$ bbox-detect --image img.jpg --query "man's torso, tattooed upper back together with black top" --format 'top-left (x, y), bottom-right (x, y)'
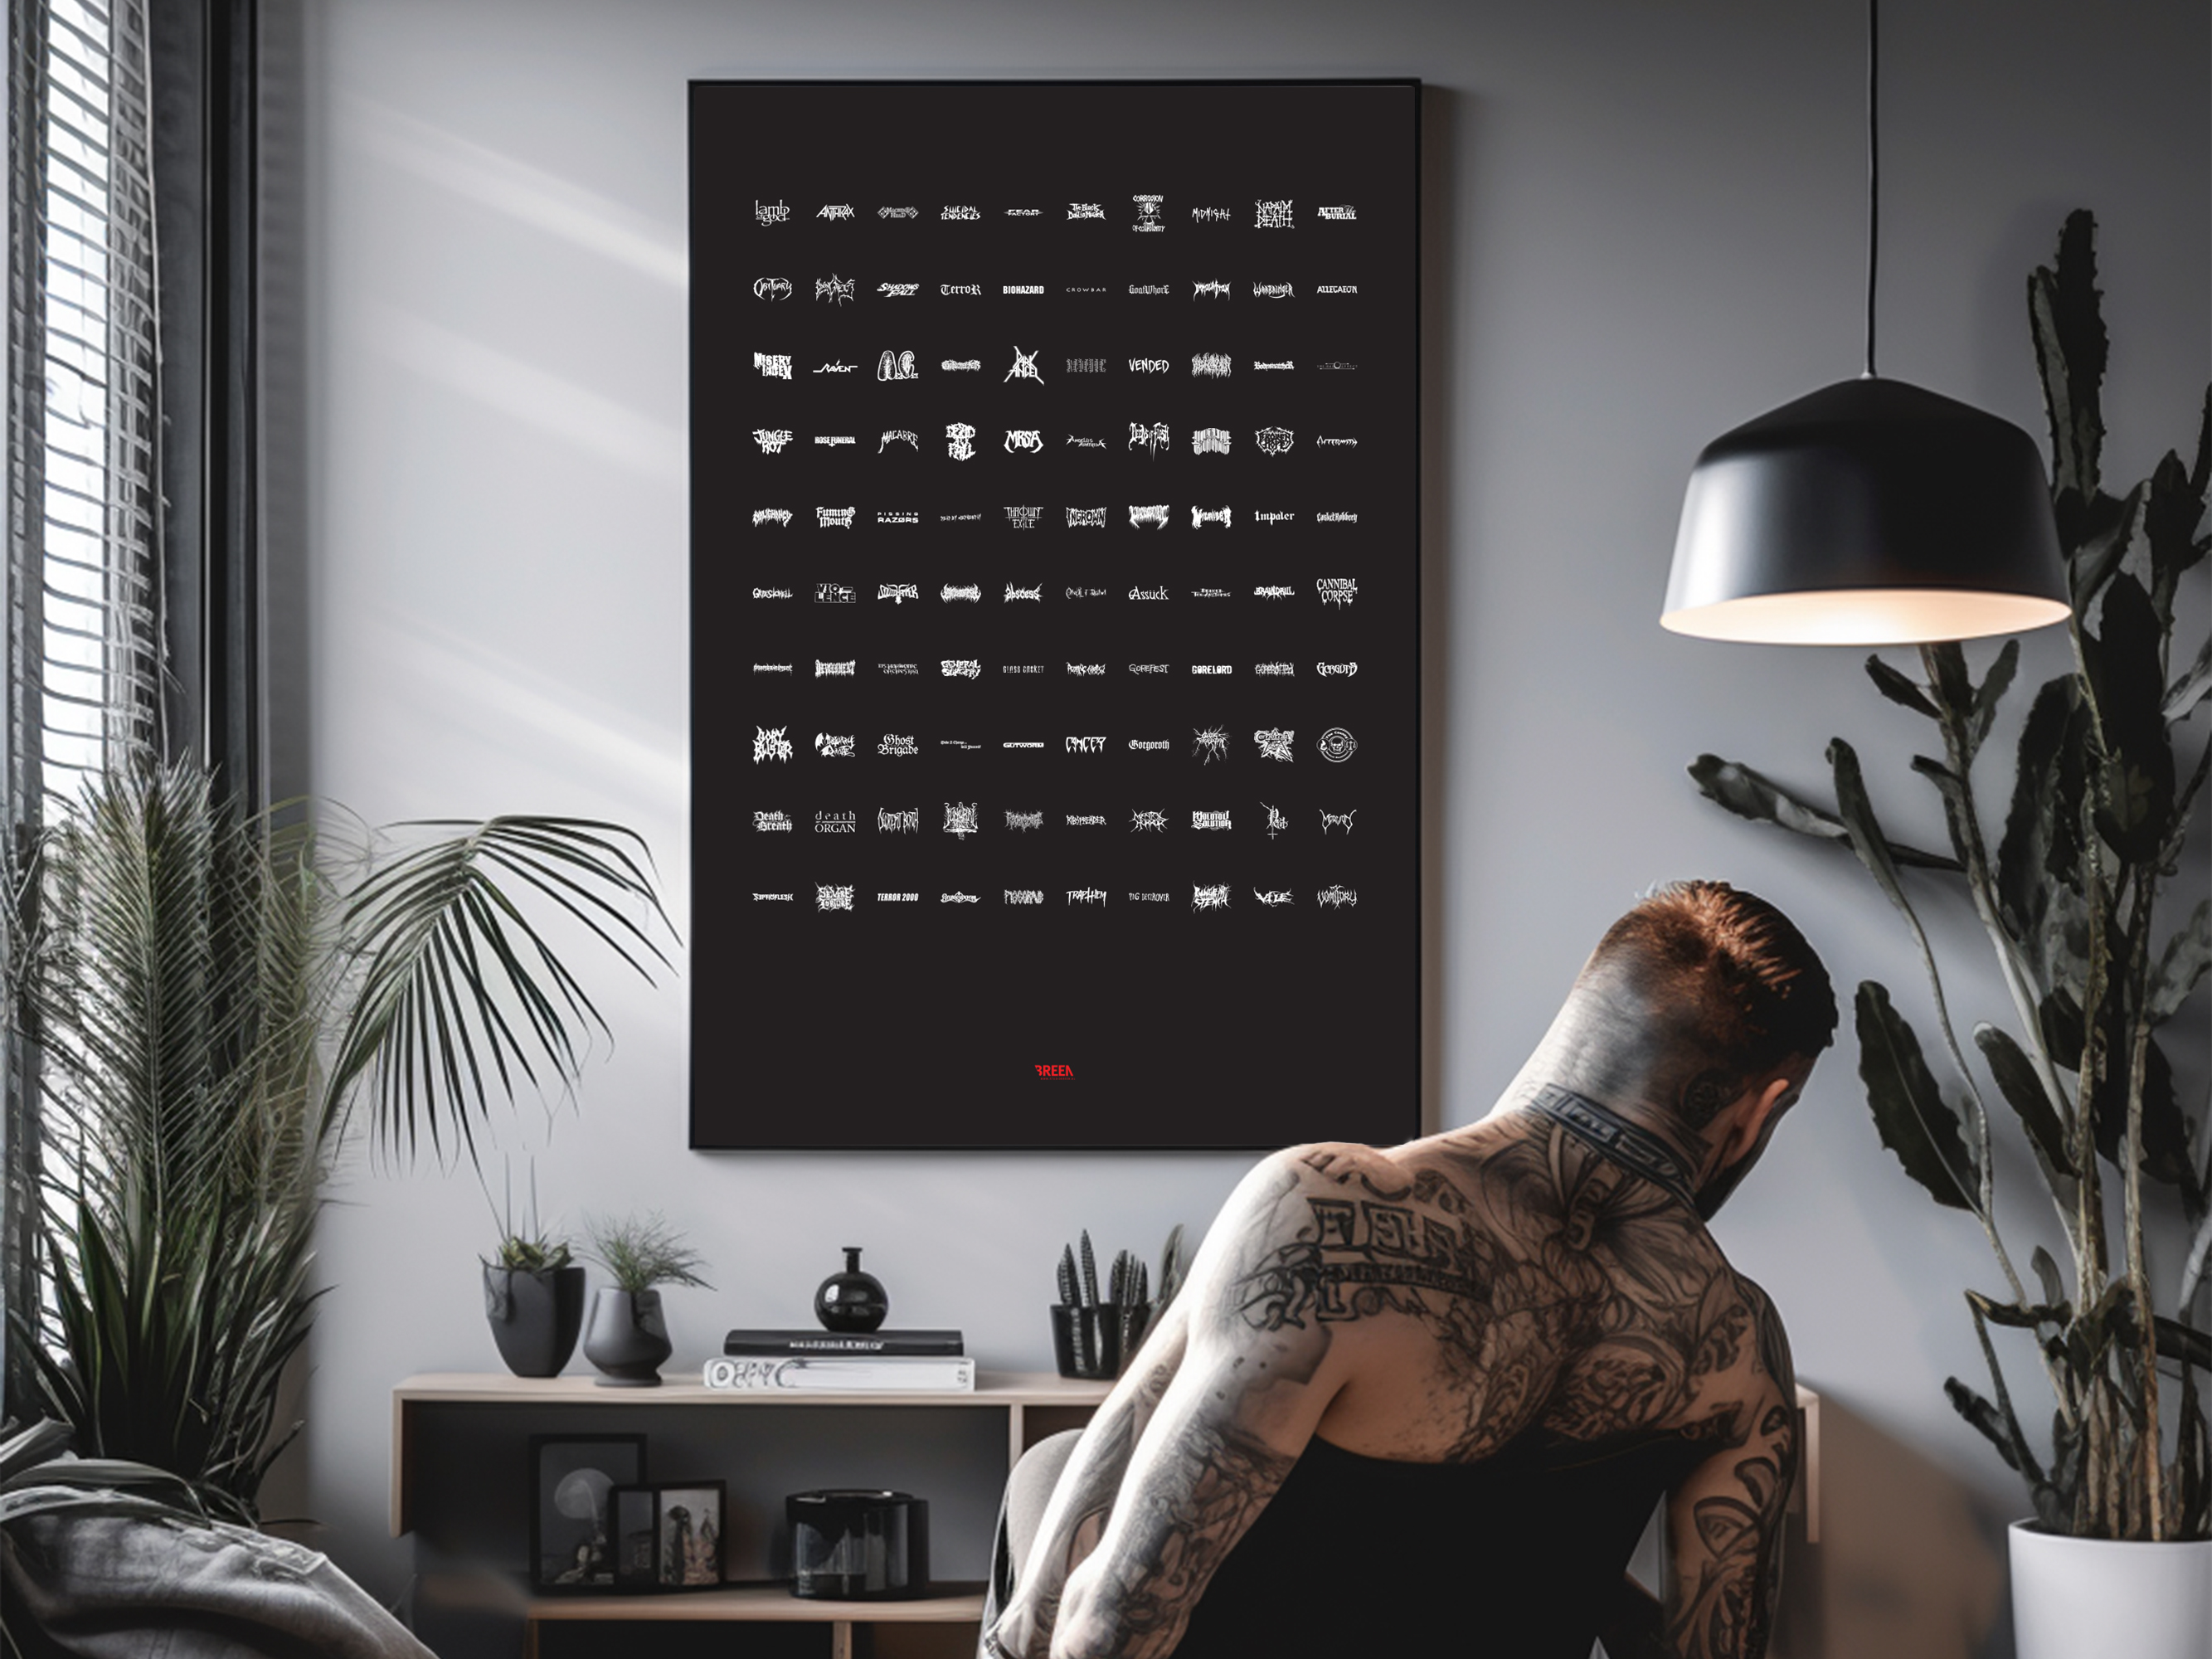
top-left (1174, 1112), bottom-right (1787, 1659)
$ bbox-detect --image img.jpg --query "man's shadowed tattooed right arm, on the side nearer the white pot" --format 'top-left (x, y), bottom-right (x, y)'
top-left (1665, 1281), bottom-right (1798, 1659)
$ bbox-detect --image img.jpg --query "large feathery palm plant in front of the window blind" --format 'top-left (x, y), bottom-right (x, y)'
top-left (0, 757), bottom-right (666, 1522)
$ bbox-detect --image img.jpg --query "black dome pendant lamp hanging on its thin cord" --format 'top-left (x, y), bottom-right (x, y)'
top-left (1659, 0), bottom-right (2073, 646)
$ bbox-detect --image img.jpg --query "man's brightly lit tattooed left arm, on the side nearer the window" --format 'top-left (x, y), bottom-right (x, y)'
top-left (999, 1152), bottom-right (1345, 1659)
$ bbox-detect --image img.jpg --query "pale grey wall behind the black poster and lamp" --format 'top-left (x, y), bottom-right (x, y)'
top-left (285, 0), bottom-right (2212, 1627)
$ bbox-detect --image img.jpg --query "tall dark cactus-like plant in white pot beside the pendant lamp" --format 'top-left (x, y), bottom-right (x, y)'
top-left (1690, 212), bottom-right (2212, 1659)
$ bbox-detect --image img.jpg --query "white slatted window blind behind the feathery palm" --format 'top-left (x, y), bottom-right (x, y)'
top-left (0, 0), bottom-right (162, 1398)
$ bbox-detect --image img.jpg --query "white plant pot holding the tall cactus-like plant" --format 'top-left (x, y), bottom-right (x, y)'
top-left (2013, 1522), bottom-right (2212, 1659)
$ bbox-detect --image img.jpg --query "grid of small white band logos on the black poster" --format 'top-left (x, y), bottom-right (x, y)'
top-left (738, 192), bottom-right (1396, 916)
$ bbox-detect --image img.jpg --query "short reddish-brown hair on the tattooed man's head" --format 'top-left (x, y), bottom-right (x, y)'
top-left (1588, 880), bottom-right (1836, 1078)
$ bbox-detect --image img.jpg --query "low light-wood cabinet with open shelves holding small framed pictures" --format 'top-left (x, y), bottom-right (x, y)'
top-left (391, 1371), bottom-right (1106, 1659)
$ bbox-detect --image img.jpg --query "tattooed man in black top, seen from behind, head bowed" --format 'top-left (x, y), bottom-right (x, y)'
top-left (984, 883), bottom-right (1836, 1659)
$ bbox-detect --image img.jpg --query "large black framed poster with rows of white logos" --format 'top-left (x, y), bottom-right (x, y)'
top-left (690, 82), bottom-right (1420, 1148)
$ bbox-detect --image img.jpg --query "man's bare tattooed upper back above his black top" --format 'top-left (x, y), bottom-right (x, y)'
top-left (1282, 1112), bottom-right (1772, 1462)
